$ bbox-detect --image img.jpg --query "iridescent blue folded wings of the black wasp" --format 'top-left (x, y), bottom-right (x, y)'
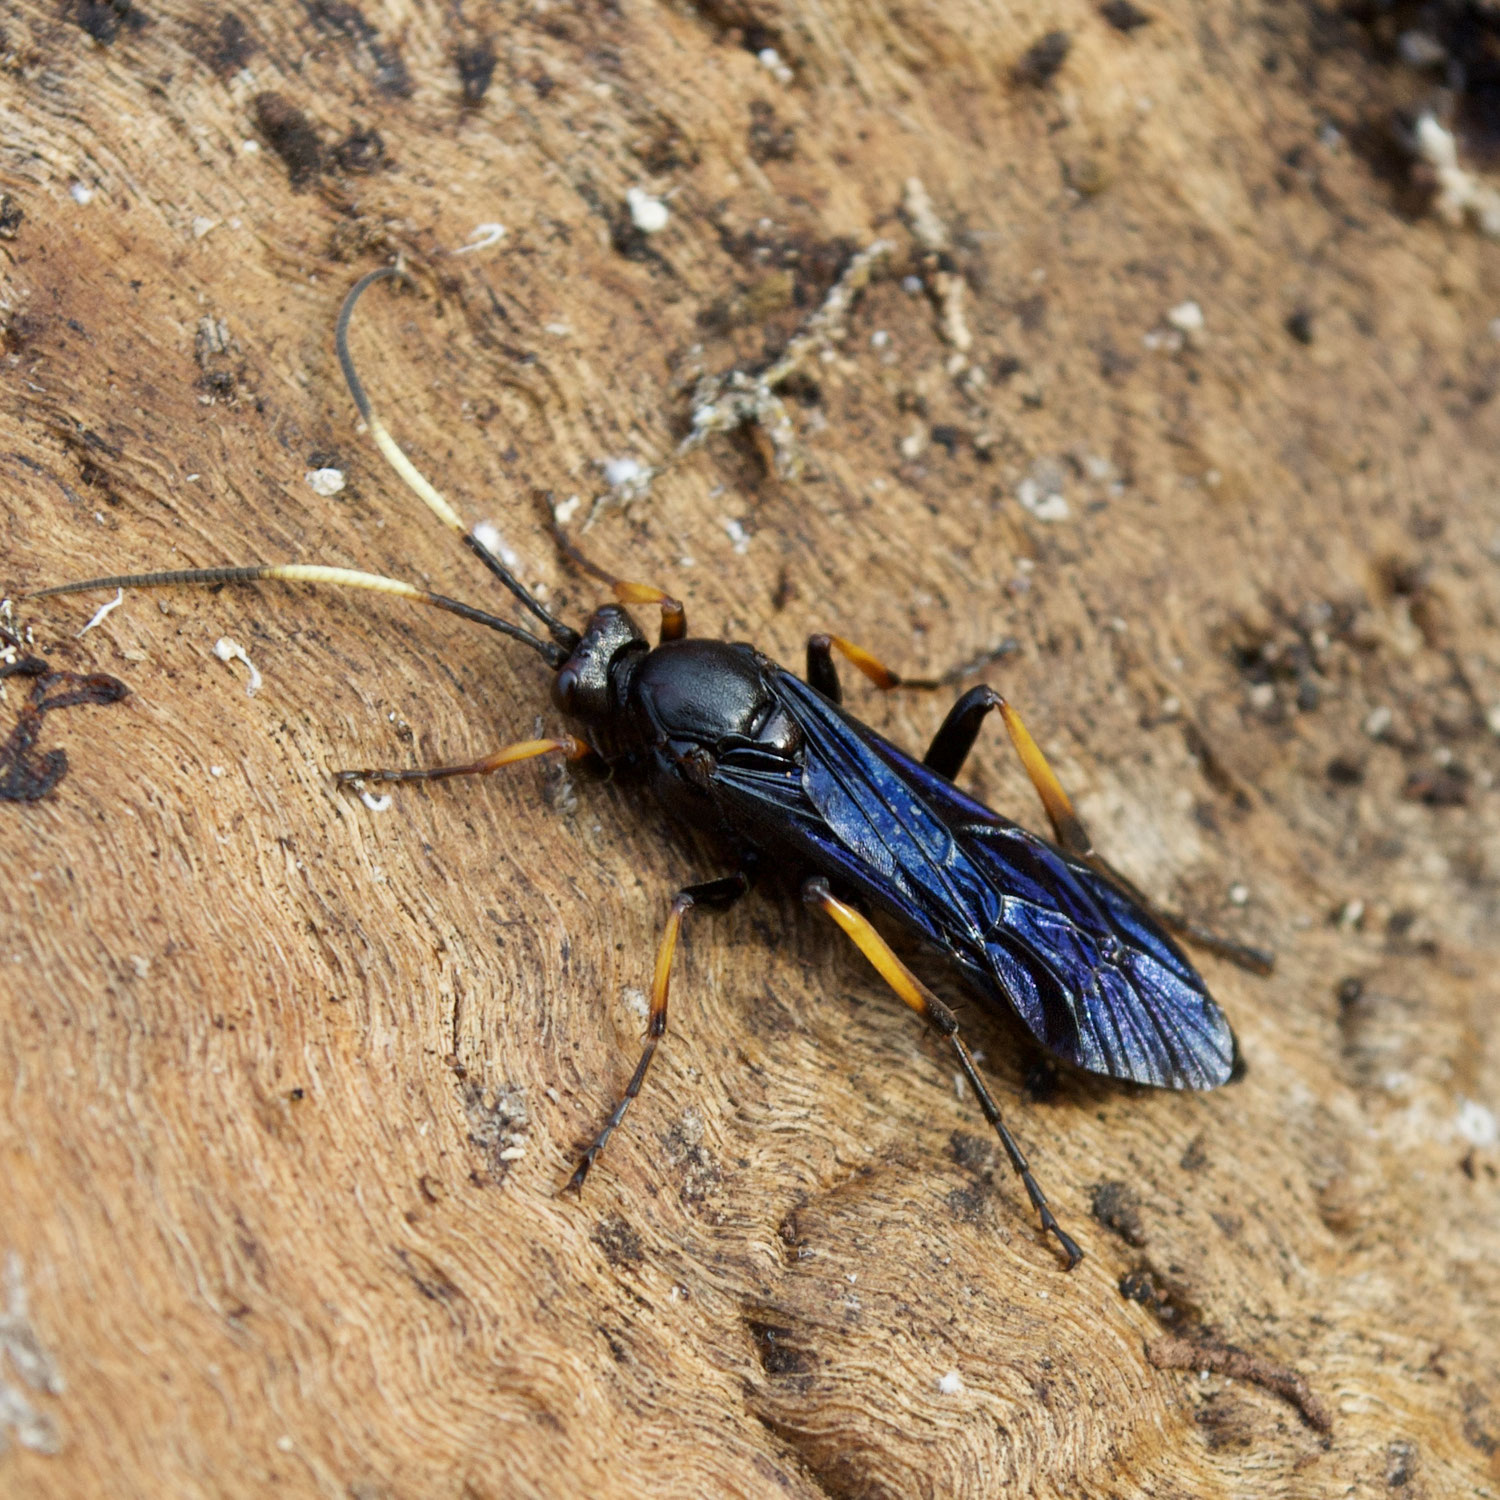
top-left (713, 669), bottom-right (1235, 1089)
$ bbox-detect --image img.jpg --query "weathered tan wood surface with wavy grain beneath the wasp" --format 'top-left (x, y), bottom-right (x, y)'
top-left (0, 0), bottom-right (1500, 1500)
